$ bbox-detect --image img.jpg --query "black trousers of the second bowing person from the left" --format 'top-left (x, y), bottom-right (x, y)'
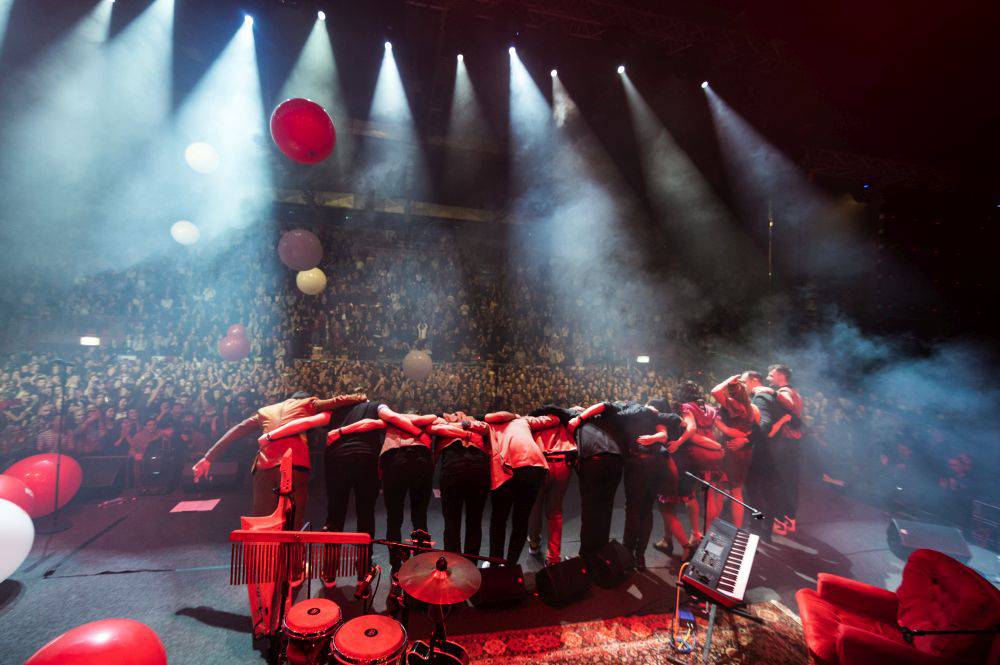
top-left (323, 448), bottom-right (379, 538)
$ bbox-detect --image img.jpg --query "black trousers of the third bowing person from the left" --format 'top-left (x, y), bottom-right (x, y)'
top-left (380, 446), bottom-right (434, 570)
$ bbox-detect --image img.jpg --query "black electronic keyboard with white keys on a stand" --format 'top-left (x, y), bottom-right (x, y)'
top-left (681, 519), bottom-right (760, 608)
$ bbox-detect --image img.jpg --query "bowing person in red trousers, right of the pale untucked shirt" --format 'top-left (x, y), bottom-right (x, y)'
top-left (528, 404), bottom-right (576, 565)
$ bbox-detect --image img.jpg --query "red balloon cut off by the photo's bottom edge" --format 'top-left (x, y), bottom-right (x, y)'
top-left (24, 619), bottom-right (167, 665)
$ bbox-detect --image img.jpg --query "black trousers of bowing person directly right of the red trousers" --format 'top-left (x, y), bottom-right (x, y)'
top-left (576, 455), bottom-right (624, 556)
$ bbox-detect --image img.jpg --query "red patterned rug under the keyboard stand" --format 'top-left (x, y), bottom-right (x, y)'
top-left (450, 600), bottom-right (807, 665)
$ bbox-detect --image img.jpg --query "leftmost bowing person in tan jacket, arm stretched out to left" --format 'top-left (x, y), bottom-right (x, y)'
top-left (193, 391), bottom-right (367, 528)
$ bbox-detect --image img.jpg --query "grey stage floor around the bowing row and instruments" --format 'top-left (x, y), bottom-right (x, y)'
top-left (0, 476), bottom-right (1000, 665)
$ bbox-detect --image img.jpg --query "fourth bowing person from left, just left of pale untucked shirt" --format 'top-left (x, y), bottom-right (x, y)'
top-left (435, 411), bottom-right (492, 556)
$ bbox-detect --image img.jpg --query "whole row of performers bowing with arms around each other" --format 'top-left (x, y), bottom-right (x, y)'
top-left (194, 379), bottom-right (800, 569)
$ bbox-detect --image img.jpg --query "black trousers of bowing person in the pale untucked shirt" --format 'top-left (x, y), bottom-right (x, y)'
top-left (490, 466), bottom-right (546, 566)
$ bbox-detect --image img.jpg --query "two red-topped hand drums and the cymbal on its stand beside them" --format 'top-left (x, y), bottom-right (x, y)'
top-left (282, 551), bottom-right (482, 665)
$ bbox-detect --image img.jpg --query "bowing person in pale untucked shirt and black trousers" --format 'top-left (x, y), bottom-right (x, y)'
top-left (483, 411), bottom-right (549, 566)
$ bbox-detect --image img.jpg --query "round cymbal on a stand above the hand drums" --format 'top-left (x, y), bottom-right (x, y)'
top-left (399, 552), bottom-right (483, 605)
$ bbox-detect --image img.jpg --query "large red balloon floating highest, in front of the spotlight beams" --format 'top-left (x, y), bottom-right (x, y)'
top-left (271, 98), bottom-right (337, 164)
